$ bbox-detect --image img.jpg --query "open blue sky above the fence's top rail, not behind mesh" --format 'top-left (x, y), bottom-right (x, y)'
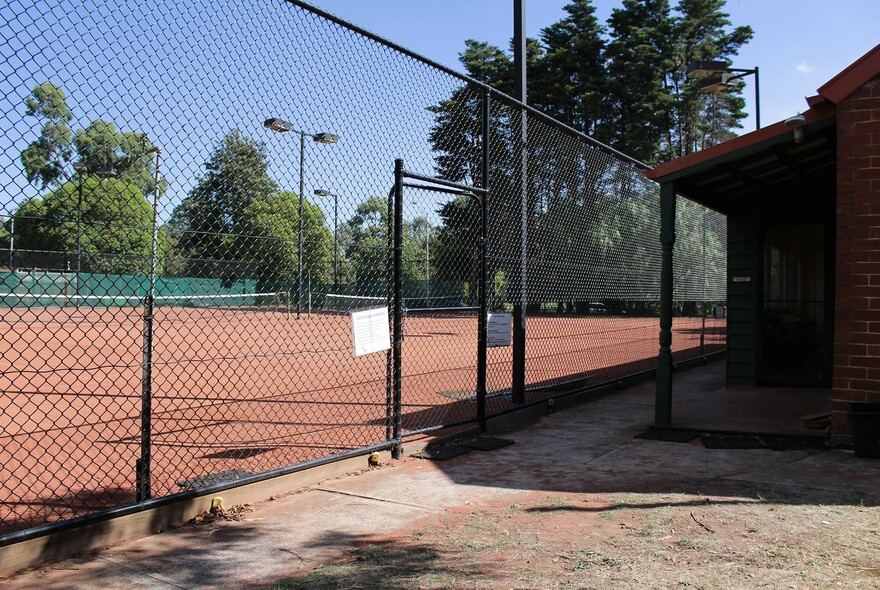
top-left (312, 0), bottom-right (880, 132)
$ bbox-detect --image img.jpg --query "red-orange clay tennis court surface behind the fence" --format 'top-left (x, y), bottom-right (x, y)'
top-left (0, 307), bottom-right (724, 533)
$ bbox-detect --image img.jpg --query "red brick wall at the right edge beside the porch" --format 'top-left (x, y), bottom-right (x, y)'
top-left (831, 77), bottom-right (880, 441)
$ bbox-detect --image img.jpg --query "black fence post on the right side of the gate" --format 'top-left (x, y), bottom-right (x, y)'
top-left (477, 89), bottom-right (490, 432)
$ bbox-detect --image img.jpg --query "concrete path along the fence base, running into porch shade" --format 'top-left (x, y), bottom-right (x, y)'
top-left (0, 369), bottom-right (880, 590)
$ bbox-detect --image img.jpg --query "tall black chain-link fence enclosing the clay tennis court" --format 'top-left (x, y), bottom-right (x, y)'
top-left (0, 0), bottom-right (726, 543)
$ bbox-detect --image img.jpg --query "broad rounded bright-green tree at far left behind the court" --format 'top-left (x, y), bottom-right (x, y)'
top-left (14, 175), bottom-right (153, 274)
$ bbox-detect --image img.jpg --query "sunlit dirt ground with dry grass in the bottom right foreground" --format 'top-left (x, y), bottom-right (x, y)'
top-left (267, 482), bottom-right (880, 590)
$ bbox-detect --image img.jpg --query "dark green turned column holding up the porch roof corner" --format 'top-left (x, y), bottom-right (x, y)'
top-left (654, 182), bottom-right (675, 426)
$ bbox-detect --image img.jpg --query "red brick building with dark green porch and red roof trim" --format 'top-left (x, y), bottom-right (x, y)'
top-left (648, 45), bottom-right (880, 441)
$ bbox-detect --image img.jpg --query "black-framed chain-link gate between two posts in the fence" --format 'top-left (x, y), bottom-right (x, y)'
top-left (388, 160), bottom-right (488, 450)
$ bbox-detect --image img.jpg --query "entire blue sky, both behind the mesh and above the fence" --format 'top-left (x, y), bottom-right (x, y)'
top-left (0, 0), bottom-right (880, 229)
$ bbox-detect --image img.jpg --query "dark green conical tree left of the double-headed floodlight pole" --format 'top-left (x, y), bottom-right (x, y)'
top-left (171, 129), bottom-right (278, 275)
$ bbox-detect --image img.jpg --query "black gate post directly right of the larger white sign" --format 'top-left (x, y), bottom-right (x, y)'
top-left (391, 159), bottom-right (403, 459)
